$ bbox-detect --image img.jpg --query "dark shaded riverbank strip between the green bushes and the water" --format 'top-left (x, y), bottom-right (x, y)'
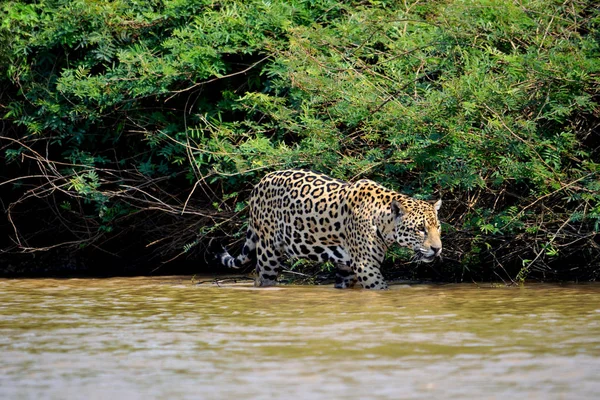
top-left (0, 250), bottom-right (600, 285)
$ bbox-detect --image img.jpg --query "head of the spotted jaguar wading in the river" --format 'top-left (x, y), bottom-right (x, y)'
top-left (391, 198), bottom-right (442, 263)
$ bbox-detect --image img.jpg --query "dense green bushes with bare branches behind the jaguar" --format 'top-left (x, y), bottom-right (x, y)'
top-left (0, 0), bottom-right (600, 280)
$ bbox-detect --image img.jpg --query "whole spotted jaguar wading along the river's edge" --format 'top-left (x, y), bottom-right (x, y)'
top-left (218, 170), bottom-right (442, 289)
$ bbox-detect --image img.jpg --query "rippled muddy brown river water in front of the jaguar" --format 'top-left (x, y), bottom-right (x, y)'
top-left (0, 277), bottom-right (600, 399)
